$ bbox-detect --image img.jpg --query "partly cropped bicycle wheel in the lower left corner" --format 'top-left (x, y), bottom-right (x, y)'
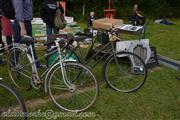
top-left (0, 80), bottom-right (26, 120)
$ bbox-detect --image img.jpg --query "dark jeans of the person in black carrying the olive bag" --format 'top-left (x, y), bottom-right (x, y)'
top-left (46, 25), bottom-right (59, 49)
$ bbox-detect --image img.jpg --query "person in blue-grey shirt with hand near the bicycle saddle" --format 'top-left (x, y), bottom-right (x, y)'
top-left (11, 0), bottom-right (42, 68)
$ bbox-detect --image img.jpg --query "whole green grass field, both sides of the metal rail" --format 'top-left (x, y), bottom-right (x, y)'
top-left (0, 20), bottom-right (180, 120)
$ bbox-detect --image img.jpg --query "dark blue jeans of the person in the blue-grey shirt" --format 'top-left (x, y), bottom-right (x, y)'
top-left (13, 20), bottom-right (41, 67)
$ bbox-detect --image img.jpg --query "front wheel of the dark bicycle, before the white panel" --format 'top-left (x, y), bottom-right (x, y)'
top-left (102, 52), bottom-right (147, 93)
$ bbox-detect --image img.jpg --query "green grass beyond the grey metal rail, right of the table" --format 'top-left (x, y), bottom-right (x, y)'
top-left (147, 20), bottom-right (180, 61)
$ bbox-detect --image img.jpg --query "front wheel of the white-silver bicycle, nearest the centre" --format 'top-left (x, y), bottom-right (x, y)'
top-left (48, 62), bottom-right (99, 112)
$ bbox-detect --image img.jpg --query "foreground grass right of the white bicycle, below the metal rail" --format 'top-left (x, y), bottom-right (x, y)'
top-left (26, 67), bottom-right (180, 120)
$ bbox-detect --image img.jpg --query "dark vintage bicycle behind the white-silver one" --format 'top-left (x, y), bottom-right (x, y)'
top-left (70, 28), bottom-right (148, 93)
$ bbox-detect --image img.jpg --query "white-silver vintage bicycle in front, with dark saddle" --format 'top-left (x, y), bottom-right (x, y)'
top-left (7, 36), bottom-right (99, 112)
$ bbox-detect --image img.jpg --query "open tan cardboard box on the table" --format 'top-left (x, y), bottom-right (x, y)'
top-left (93, 18), bottom-right (123, 30)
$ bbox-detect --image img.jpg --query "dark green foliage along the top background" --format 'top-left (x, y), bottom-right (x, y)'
top-left (33, 0), bottom-right (180, 19)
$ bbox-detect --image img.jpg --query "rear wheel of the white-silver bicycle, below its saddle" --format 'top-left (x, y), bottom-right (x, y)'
top-left (8, 48), bottom-right (32, 89)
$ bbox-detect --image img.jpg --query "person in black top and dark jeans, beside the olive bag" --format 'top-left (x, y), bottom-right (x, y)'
top-left (40, 0), bottom-right (64, 49)
